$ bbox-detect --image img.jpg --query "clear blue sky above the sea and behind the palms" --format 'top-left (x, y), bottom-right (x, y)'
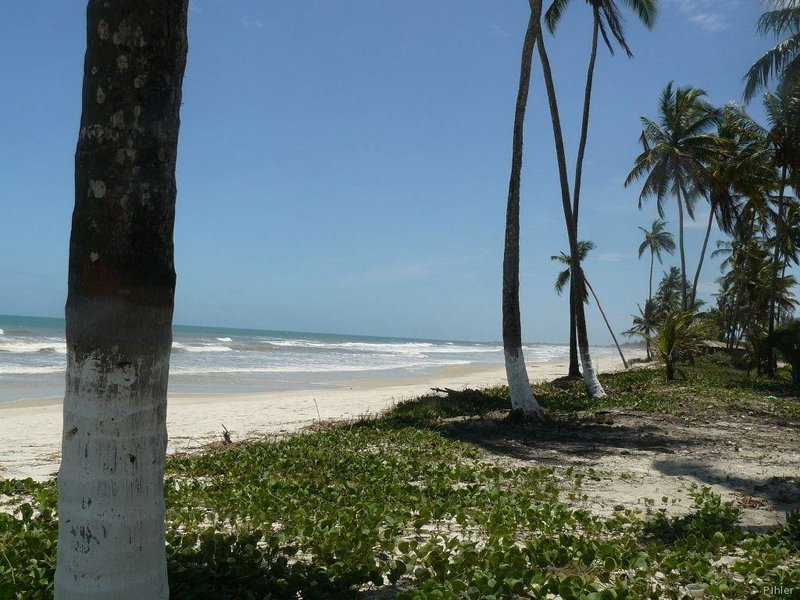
top-left (0, 0), bottom-right (788, 344)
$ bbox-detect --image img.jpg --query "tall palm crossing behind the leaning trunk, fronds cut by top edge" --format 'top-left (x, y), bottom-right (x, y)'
top-left (545, 0), bottom-right (657, 377)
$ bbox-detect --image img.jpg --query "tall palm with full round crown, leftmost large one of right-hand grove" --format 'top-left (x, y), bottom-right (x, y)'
top-left (625, 82), bottom-right (718, 310)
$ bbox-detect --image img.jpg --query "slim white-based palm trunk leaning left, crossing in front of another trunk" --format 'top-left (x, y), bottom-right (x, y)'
top-left (537, 35), bottom-right (606, 398)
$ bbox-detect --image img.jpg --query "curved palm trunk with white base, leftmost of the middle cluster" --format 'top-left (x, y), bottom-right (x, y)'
top-left (503, 0), bottom-right (542, 418)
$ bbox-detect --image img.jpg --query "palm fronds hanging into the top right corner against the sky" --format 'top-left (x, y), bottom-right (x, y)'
top-left (744, 0), bottom-right (800, 100)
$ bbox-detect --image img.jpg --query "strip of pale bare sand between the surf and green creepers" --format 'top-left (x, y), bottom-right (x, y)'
top-left (0, 350), bottom-right (641, 480)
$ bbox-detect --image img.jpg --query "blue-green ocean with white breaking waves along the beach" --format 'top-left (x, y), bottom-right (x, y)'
top-left (0, 315), bottom-right (612, 402)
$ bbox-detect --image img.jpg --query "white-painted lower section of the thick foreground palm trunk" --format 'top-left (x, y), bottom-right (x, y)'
top-left (56, 351), bottom-right (169, 600)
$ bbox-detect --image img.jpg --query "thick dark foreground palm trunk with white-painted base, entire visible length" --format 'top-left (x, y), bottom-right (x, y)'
top-left (55, 0), bottom-right (188, 599)
